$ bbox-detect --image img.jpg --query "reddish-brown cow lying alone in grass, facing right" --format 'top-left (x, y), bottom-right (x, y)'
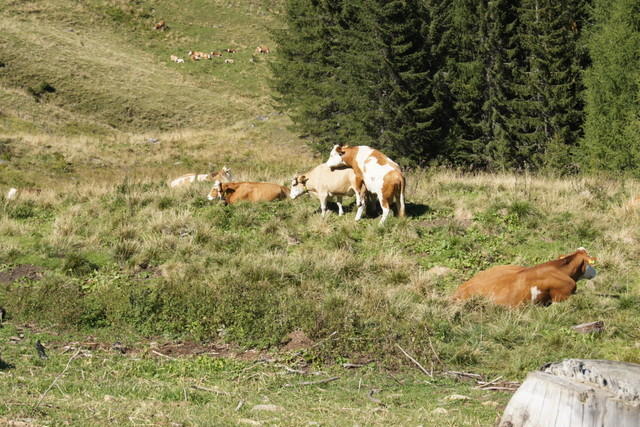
top-left (454, 248), bottom-right (596, 307)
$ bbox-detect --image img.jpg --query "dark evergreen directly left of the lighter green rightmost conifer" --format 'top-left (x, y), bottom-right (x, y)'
top-left (513, 0), bottom-right (585, 168)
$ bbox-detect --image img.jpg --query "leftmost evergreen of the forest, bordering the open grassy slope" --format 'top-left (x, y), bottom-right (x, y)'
top-left (272, 0), bottom-right (352, 153)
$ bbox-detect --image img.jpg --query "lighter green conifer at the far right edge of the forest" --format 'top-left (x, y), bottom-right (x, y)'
top-left (581, 0), bottom-right (640, 173)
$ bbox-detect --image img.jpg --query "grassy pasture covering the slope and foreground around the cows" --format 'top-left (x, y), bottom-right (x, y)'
top-left (0, 0), bottom-right (640, 425)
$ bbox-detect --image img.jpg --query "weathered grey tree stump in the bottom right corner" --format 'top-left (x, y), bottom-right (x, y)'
top-left (499, 359), bottom-right (640, 427)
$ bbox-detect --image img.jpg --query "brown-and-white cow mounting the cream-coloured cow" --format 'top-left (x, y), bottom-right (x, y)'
top-left (326, 145), bottom-right (406, 224)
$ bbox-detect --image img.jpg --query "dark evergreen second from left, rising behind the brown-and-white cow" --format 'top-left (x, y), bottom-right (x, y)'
top-left (358, 0), bottom-right (447, 164)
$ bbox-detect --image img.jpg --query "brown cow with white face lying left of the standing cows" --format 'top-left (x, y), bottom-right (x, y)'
top-left (208, 181), bottom-right (289, 205)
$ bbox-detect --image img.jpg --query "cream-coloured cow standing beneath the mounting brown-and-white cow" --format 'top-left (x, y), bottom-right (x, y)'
top-left (291, 163), bottom-right (361, 216)
